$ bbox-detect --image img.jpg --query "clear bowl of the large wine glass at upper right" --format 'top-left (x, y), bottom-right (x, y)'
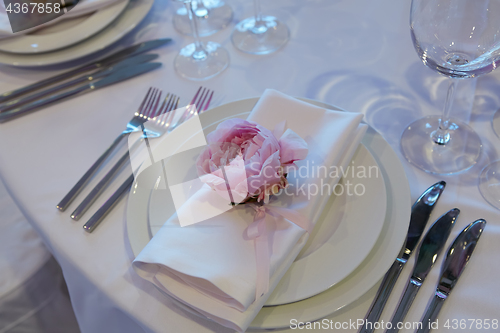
top-left (410, 0), bottom-right (500, 78)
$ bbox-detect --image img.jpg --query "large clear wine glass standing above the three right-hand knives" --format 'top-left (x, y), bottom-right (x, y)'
top-left (401, 0), bottom-right (500, 174)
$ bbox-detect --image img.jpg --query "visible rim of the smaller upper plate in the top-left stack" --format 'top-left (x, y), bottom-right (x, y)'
top-left (0, 0), bottom-right (129, 54)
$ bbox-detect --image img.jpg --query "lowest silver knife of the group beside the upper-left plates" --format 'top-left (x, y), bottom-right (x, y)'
top-left (0, 62), bottom-right (161, 122)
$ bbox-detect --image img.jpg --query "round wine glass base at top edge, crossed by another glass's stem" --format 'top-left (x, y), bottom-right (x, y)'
top-left (173, 0), bottom-right (233, 37)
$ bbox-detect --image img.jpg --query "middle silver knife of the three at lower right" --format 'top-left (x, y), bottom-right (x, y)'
top-left (385, 208), bottom-right (460, 333)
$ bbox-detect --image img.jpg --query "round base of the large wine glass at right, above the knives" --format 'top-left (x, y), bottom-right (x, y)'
top-left (401, 116), bottom-right (482, 174)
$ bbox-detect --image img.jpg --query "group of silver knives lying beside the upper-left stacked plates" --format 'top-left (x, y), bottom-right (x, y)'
top-left (0, 39), bottom-right (171, 122)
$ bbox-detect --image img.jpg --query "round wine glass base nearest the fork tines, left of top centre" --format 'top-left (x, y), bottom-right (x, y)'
top-left (174, 42), bottom-right (229, 81)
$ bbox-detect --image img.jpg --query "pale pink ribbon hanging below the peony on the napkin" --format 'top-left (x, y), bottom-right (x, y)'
top-left (247, 204), bottom-right (313, 299)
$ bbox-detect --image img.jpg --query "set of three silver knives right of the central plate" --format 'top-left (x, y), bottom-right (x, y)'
top-left (358, 181), bottom-right (486, 333)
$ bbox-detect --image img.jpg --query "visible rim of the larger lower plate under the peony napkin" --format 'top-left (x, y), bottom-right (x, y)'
top-left (127, 98), bottom-right (410, 328)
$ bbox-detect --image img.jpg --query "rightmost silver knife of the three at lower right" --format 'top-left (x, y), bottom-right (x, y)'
top-left (415, 219), bottom-right (486, 333)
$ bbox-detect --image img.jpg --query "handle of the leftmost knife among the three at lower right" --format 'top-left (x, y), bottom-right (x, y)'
top-left (358, 258), bottom-right (406, 333)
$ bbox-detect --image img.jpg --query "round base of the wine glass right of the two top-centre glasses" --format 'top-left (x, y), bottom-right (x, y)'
top-left (231, 16), bottom-right (290, 54)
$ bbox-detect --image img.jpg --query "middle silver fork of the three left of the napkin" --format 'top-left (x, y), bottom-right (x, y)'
top-left (71, 91), bottom-right (179, 221)
